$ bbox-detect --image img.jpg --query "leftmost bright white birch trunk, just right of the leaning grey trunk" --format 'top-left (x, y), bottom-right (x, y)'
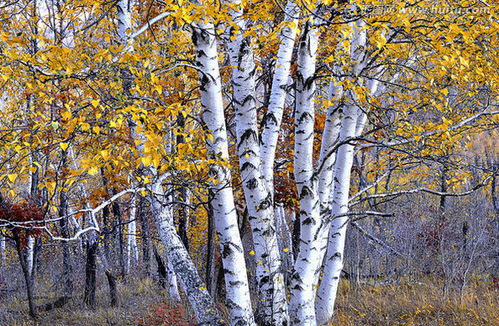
top-left (192, 24), bottom-right (255, 325)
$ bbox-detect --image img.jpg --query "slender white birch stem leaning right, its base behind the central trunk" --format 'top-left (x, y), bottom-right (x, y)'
top-left (260, 0), bottom-right (299, 190)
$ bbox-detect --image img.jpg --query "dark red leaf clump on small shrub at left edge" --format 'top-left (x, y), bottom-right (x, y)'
top-left (0, 202), bottom-right (43, 248)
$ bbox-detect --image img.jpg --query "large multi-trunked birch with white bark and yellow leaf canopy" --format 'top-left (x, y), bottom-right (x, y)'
top-left (0, 0), bottom-right (497, 325)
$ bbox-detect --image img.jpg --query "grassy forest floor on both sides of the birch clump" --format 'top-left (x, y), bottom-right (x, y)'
top-left (0, 279), bottom-right (499, 326)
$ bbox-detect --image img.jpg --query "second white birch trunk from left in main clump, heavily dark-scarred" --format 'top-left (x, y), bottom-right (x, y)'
top-left (229, 2), bottom-right (289, 326)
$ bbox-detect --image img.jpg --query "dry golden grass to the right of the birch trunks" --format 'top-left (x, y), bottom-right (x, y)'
top-left (332, 281), bottom-right (499, 326)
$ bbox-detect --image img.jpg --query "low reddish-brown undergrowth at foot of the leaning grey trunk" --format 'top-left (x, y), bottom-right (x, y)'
top-left (137, 303), bottom-right (196, 326)
